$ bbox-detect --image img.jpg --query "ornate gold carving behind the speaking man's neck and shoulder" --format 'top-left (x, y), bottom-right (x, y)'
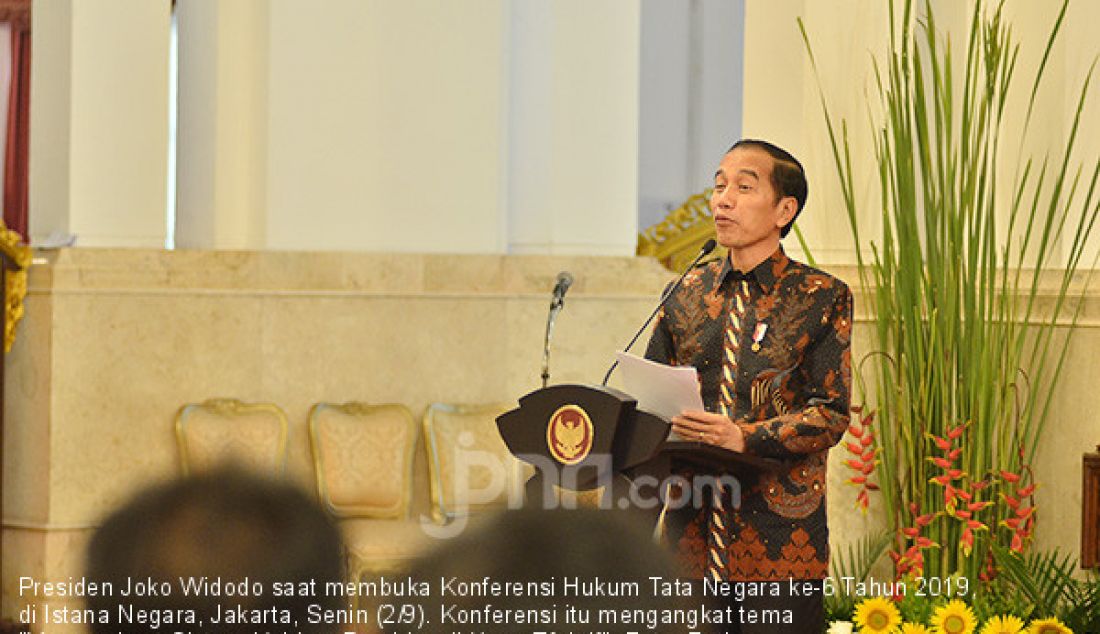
top-left (637, 189), bottom-right (724, 273)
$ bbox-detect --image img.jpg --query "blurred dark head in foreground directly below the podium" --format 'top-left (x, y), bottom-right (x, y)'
top-left (387, 509), bottom-right (723, 634)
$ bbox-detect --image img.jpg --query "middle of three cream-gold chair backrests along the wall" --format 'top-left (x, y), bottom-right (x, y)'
top-left (309, 402), bottom-right (417, 517)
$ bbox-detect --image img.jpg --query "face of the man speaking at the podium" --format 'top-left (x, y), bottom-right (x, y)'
top-left (711, 146), bottom-right (798, 251)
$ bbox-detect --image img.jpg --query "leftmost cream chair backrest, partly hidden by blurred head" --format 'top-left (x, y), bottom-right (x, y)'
top-left (175, 398), bottom-right (287, 477)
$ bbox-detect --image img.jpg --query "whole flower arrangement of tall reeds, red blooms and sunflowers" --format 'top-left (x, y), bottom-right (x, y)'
top-left (799, 0), bottom-right (1100, 634)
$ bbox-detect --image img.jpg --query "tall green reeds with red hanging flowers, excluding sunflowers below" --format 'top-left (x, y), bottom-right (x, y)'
top-left (799, 0), bottom-right (1100, 579)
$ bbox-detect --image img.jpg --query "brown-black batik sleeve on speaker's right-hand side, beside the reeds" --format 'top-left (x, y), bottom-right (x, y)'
top-left (736, 283), bottom-right (851, 460)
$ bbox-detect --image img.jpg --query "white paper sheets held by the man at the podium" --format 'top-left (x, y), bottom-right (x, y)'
top-left (616, 352), bottom-right (704, 429)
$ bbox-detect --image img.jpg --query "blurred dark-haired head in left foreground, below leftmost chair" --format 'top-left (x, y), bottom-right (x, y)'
top-left (87, 469), bottom-right (344, 634)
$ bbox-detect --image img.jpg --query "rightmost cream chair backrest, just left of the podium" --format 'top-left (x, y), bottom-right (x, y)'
top-left (424, 403), bottom-right (530, 523)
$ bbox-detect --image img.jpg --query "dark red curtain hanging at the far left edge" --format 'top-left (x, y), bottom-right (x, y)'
top-left (0, 0), bottom-right (31, 240)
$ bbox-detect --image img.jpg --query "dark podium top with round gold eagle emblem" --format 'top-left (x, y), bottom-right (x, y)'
top-left (496, 384), bottom-right (782, 507)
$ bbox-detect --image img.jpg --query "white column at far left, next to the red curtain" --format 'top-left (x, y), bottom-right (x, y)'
top-left (29, 0), bottom-right (171, 248)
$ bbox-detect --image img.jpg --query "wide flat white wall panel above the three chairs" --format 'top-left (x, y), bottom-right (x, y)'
top-left (266, 0), bottom-right (507, 253)
